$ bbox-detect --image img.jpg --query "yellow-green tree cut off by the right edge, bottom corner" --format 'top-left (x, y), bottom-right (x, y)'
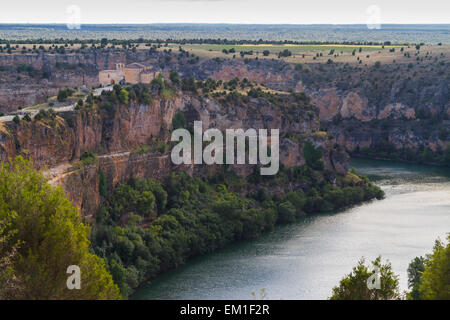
top-left (419, 234), bottom-right (450, 300)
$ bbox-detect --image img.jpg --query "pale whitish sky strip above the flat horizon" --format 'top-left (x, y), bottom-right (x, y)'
top-left (0, 0), bottom-right (450, 24)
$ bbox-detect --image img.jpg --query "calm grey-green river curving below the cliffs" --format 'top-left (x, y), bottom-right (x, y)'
top-left (133, 159), bottom-right (450, 300)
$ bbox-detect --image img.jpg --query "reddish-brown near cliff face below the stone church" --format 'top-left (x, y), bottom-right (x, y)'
top-left (0, 92), bottom-right (348, 216)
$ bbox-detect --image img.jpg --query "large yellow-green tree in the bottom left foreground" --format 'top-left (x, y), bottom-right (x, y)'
top-left (0, 157), bottom-right (120, 299)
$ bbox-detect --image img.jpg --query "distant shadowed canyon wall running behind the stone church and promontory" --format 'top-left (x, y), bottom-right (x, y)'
top-left (0, 49), bottom-right (450, 157)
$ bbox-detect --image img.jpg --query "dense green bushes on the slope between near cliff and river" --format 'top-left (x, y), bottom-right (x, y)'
top-left (92, 166), bottom-right (383, 297)
